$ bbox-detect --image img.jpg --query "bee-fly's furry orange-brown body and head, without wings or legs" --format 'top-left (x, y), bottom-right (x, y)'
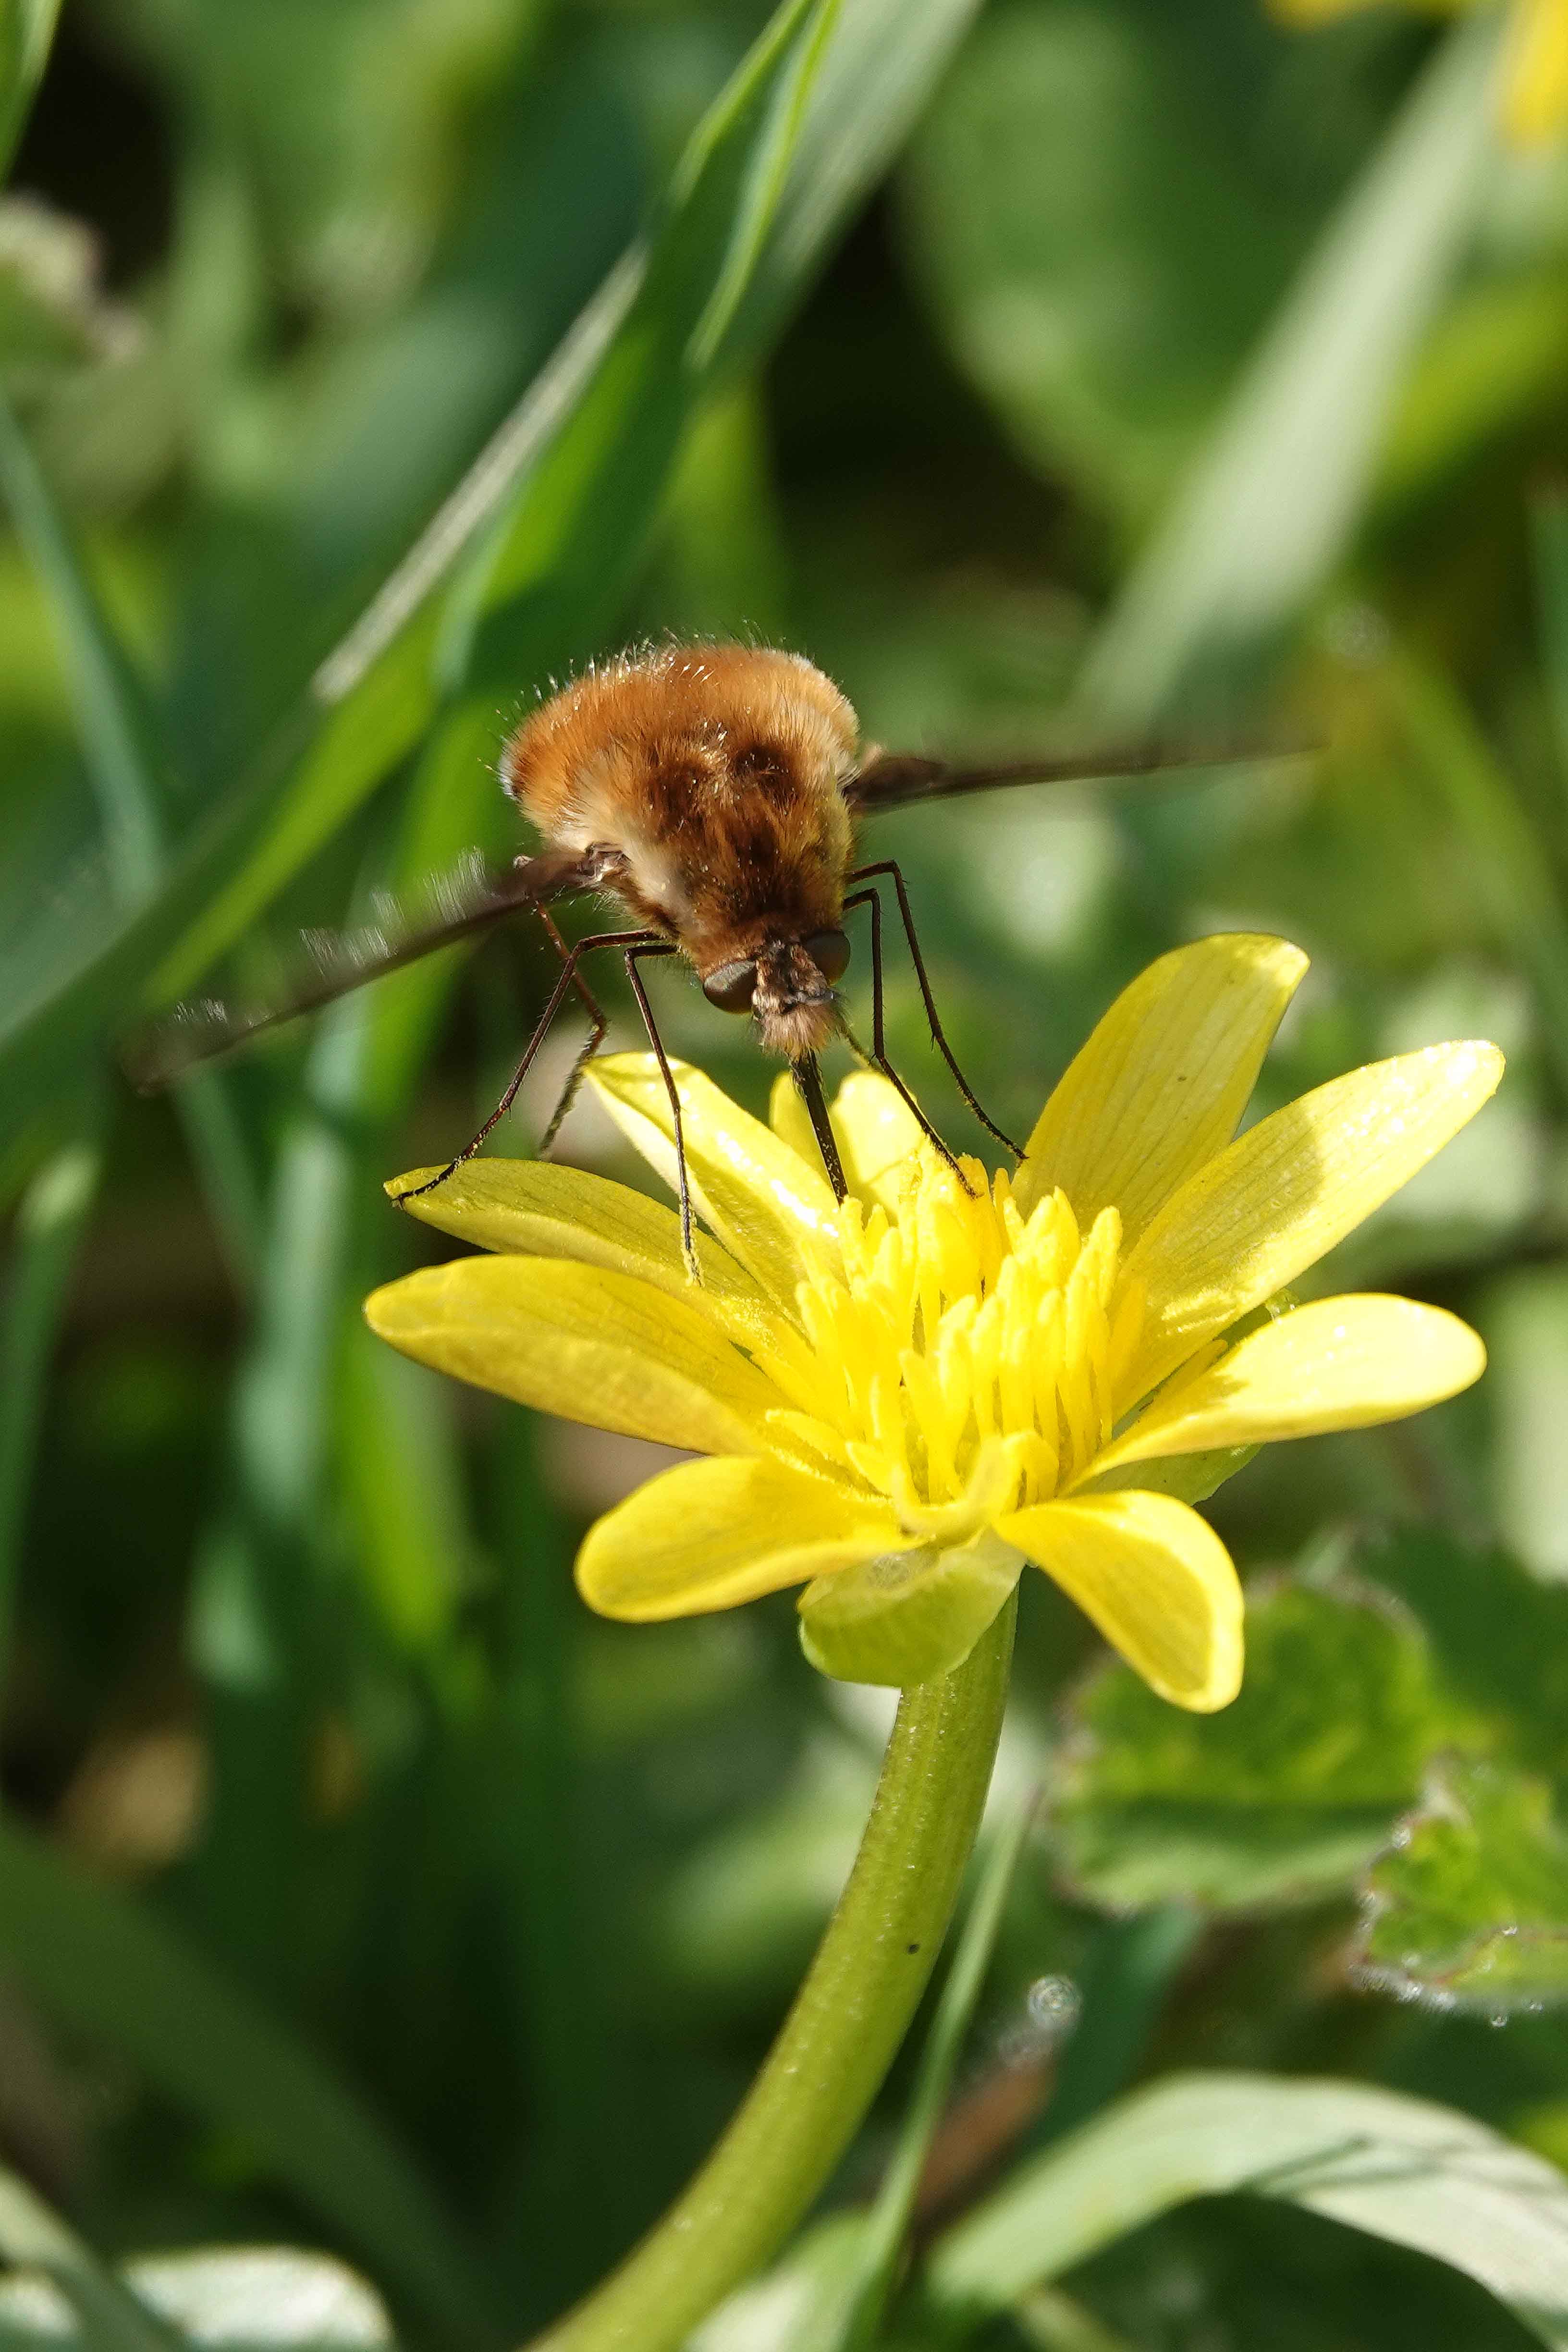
top-left (501, 645), bottom-right (860, 1061)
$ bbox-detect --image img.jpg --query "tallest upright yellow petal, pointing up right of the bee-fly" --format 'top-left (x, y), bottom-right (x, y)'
top-left (1013, 931), bottom-right (1307, 1249)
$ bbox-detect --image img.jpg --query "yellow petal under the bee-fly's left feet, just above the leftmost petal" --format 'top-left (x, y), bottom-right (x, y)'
top-left (386, 1160), bottom-right (769, 1329)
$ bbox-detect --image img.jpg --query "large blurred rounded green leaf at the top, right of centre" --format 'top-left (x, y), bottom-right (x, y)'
top-left (905, 0), bottom-right (1300, 525)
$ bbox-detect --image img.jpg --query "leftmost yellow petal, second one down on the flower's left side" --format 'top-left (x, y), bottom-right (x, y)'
top-left (365, 1258), bottom-right (783, 1454)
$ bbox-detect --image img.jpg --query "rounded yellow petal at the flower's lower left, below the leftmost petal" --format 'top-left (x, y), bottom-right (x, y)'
top-left (576, 1458), bottom-right (900, 1620)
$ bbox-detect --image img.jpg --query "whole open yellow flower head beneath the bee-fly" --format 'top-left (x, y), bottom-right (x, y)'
top-left (367, 934), bottom-right (1502, 1710)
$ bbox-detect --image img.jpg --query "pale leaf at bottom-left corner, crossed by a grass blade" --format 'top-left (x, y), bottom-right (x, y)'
top-left (0, 2246), bottom-right (392, 2352)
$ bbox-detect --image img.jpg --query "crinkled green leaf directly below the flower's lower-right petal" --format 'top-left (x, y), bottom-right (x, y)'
top-left (1053, 1583), bottom-right (1453, 1910)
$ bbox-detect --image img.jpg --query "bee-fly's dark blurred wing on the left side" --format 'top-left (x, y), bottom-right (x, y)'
top-left (120, 854), bottom-right (585, 1094)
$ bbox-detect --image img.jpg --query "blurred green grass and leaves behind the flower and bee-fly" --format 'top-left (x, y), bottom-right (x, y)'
top-left (0, 0), bottom-right (1568, 2352)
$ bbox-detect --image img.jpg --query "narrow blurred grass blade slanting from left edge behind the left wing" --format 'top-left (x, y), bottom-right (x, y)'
top-left (0, 393), bottom-right (261, 1286)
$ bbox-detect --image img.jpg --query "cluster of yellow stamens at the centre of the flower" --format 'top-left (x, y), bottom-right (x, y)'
top-left (762, 1150), bottom-right (1138, 1543)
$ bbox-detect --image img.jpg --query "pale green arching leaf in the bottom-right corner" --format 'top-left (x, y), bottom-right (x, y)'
top-left (926, 2072), bottom-right (1568, 2352)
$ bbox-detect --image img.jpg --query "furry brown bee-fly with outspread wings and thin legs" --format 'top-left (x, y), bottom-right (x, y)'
top-left (132, 645), bottom-right (1269, 1265)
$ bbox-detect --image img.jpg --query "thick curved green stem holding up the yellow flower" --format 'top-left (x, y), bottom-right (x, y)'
top-left (534, 1594), bottom-right (1016, 2352)
